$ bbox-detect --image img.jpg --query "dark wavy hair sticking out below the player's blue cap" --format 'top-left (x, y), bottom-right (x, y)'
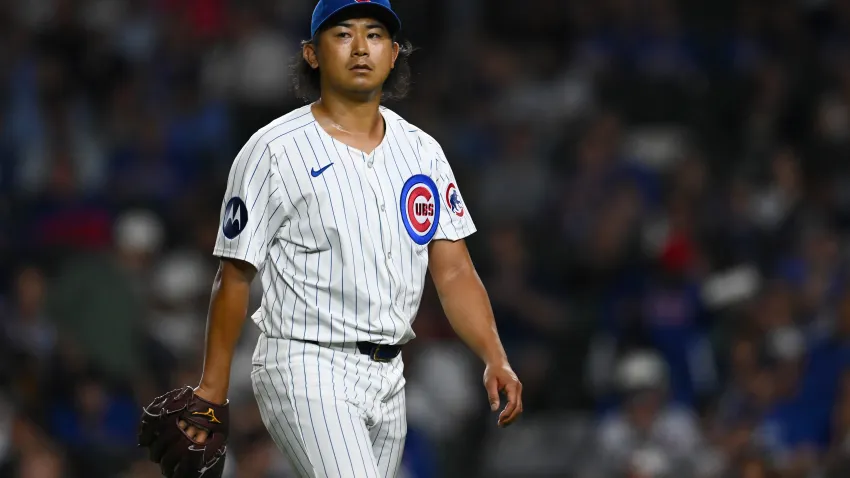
top-left (290, 29), bottom-right (414, 103)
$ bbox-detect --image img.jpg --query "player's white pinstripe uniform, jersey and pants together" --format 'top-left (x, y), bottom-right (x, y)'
top-left (214, 106), bottom-right (475, 478)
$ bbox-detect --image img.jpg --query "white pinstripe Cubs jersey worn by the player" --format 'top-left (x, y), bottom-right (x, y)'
top-left (214, 105), bottom-right (475, 344)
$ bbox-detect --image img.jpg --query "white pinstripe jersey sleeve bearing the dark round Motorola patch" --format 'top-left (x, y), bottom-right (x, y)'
top-left (213, 132), bottom-right (287, 270)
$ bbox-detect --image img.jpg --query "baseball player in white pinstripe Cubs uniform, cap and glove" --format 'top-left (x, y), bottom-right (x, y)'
top-left (139, 0), bottom-right (522, 478)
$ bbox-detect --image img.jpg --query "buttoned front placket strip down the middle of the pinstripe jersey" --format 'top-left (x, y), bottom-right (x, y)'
top-left (365, 147), bottom-right (401, 330)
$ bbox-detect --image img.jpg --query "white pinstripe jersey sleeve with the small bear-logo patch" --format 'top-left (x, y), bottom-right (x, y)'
top-left (434, 146), bottom-right (476, 241)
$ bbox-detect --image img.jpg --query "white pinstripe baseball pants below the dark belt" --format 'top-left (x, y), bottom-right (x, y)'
top-left (251, 336), bottom-right (407, 478)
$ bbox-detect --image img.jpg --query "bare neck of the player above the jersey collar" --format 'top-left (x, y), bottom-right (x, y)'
top-left (313, 95), bottom-right (384, 139)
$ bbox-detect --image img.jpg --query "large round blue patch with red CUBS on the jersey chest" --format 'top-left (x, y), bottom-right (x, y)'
top-left (399, 174), bottom-right (440, 246)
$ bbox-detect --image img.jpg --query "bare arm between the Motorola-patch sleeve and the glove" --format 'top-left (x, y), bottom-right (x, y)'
top-left (200, 262), bottom-right (251, 402)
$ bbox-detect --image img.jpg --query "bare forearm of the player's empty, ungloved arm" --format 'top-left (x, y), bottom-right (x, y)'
top-left (435, 264), bottom-right (507, 364)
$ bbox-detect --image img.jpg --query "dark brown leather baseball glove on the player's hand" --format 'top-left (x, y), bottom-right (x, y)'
top-left (139, 386), bottom-right (229, 478)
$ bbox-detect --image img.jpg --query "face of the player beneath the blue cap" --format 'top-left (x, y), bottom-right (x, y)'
top-left (304, 18), bottom-right (399, 95)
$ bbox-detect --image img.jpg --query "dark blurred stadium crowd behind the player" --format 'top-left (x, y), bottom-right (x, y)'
top-left (0, 0), bottom-right (850, 478)
